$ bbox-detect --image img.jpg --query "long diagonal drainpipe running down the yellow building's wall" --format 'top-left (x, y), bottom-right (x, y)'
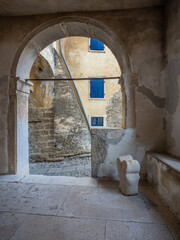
top-left (56, 39), bottom-right (91, 132)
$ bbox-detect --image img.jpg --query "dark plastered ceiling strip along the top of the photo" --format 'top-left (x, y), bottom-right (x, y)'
top-left (0, 0), bottom-right (163, 16)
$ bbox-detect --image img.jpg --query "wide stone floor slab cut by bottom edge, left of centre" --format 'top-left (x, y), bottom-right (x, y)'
top-left (9, 215), bottom-right (105, 240)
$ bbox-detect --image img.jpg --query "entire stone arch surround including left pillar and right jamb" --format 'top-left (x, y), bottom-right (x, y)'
top-left (9, 18), bottom-right (134, 173)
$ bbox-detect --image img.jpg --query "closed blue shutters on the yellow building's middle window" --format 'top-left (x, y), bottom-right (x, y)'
top-left (90, 79), bottom-right (104, 98)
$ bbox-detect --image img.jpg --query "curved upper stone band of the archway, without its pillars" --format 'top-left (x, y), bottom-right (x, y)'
top-left (11, 17), bottom-right (131, 79)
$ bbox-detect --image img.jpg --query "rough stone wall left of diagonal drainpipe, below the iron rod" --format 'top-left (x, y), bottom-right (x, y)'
top-left (54, 81), bottom-right (91, 156)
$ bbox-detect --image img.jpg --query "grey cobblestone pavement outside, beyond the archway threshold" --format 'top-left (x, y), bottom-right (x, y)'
top-left (29, 157), bottom-right (91, 177)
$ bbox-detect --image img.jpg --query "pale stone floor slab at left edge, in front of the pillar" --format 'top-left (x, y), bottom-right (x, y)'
top-left (0, 183), bottom-right (71, 215)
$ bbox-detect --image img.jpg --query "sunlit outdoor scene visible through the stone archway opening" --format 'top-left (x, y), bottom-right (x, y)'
top-left (29, 37), bottom-right (122, 177)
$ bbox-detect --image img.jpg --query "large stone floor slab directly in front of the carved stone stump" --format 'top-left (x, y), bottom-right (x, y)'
top-left (58, 186), bottom-right (152, 222)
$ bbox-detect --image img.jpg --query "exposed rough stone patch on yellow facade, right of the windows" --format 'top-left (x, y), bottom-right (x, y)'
top-left (106, 90), bottom-right (122, 128)
